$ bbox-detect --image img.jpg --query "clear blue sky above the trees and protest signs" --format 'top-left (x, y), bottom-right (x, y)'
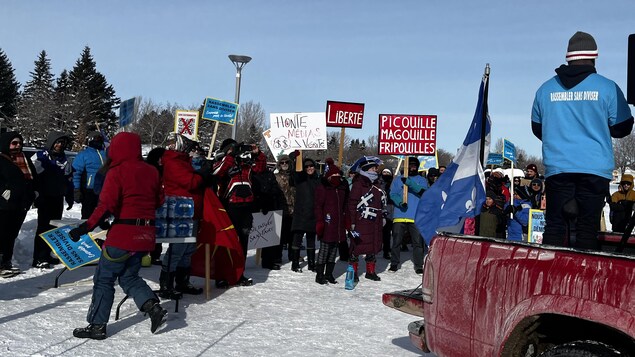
top-left (0, 0), bottom-right (635, 155)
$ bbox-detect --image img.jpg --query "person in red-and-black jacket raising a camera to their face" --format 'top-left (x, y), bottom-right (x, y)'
top-left (212, 139), bottom-right (267, 288)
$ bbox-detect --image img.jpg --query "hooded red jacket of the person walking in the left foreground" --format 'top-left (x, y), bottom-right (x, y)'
top-left (86, 132), bottom-right (163, 252)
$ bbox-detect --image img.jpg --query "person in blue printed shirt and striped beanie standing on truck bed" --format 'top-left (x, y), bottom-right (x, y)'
top-left (531, 31), bottom-right (633, 249)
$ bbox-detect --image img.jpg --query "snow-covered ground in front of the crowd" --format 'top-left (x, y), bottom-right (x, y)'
top-left (0, 205), bottom-right (432, 357)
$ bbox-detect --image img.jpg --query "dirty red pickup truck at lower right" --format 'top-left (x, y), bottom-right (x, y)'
top-left (383, 233), bottom-right (635, 357)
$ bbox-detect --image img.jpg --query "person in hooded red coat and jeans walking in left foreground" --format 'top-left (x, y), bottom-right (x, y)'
top-left (69, 132), bottom-right (167, 340)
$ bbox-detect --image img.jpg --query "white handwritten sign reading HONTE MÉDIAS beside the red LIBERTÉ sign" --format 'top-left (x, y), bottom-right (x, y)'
top-left (269, 113), bottom-right (326, 152)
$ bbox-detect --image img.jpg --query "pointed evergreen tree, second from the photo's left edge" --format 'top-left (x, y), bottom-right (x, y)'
top-left (15, 51), bottom-right (56, 146)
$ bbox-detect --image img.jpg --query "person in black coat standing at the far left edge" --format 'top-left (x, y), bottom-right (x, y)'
top-left (0, 131), bottom-right (36, 277)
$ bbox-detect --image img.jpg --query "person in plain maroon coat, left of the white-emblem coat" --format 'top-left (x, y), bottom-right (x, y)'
top-left (314, 157), bottom-right (348, 285)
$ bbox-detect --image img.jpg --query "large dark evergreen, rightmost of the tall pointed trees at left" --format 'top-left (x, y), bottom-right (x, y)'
top-left (68, 46), bottom-right (121, 143)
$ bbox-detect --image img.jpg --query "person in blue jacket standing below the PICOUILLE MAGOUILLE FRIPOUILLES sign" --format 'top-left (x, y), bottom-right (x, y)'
top-left (389, 156), bottom-right (428, 274)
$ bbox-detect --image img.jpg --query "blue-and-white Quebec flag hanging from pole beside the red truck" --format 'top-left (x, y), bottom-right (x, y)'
top-left (415, 72), bottom-right (491, 244)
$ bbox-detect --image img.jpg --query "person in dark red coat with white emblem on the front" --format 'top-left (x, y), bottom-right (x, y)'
top-left (346, 157), bottom-right (387, 281)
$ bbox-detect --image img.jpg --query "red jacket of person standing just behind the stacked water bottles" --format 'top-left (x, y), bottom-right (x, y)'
top-left (161, 150), bottom-right (205, 219)
